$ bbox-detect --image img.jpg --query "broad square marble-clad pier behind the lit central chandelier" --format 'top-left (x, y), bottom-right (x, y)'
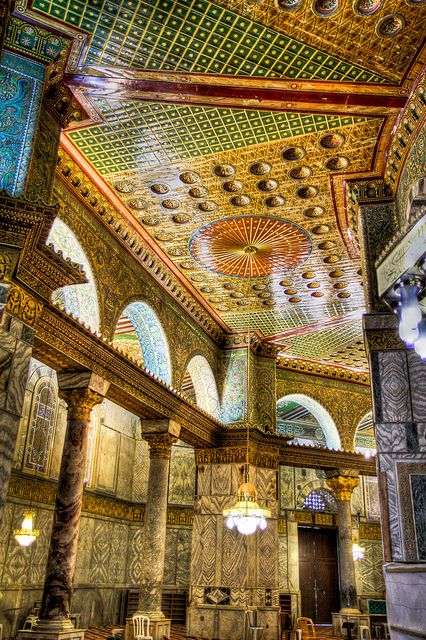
top-left (187, 440), bottom-right (280, 640)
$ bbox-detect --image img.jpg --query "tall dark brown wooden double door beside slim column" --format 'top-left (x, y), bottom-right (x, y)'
top-left (298, 527), bottom-right (340, 624)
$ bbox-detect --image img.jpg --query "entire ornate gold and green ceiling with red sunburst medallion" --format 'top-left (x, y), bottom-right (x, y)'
top-left (14, 0), bottom-right (426, 370)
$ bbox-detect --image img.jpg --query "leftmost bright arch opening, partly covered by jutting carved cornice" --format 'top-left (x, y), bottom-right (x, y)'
top-left (47, 218), bottom-right (100, 331)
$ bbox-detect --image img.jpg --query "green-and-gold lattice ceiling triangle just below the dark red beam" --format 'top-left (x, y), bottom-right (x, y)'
top-left (69, 98), bottom-right (365, 176)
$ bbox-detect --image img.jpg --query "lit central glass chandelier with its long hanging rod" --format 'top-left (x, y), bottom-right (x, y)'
top-left (223, 245), bottom-right (271, 536)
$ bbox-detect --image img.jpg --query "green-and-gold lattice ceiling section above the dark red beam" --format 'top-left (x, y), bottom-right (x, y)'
top-left (33, 0), bottom-right (386, 82)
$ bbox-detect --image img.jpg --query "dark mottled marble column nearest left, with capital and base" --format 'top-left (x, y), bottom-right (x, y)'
top-left (18, 372), bottom-right (108, 640)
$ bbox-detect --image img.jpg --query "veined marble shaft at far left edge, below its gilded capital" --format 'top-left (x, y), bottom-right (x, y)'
top-left (0, 314), bottom-right (34, 525)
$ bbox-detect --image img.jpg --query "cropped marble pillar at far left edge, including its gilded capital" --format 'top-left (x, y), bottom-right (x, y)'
top-left (0, 282), bottom-right (42, 525)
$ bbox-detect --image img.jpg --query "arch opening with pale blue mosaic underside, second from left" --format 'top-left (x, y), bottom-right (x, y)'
top-left (114, 302), bottom-right (172, 384)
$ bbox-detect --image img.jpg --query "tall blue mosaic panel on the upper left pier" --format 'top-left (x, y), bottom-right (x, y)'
top-left (0, 51), bottom-right (44, 197)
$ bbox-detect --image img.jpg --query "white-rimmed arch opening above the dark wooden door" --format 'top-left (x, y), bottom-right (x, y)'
top-left (277, 393), bottom-right (341, 449)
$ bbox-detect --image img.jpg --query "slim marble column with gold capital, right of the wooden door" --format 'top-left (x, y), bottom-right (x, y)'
top-left (326, 469), bottom-right (359, 613)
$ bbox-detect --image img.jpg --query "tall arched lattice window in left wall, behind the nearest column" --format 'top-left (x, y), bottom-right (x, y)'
top-left (24, 376), bottom-right (58, 474)
